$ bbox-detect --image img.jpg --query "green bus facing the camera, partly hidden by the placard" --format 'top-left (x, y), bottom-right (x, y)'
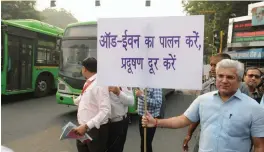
top-left (56, 22), bottom-right (174, 113)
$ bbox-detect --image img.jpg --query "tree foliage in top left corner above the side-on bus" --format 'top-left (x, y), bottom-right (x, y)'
top-left (1, 1), bottom-right (42, 20)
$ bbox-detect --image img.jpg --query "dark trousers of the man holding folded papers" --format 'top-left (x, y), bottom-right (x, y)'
top-left (76, 124), bottom-right (109, 152)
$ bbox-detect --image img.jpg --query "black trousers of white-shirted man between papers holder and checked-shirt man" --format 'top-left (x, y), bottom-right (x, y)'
top-left (107, 117), bottom-right (128, 152)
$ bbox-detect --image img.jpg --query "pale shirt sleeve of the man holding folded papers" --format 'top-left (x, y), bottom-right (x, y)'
top-left (87, 86), bottom-right (111, 129)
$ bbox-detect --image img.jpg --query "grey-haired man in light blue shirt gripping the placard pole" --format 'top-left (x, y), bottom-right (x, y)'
top-left (142, 59), bottom-right (264, 152)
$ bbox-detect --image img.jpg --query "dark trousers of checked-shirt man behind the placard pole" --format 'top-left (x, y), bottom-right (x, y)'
top-left (139, 116), bottom-right (156, 152)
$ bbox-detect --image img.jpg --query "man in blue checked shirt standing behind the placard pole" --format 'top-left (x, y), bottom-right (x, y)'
top-left (135, 88), bottom-right (162, 152)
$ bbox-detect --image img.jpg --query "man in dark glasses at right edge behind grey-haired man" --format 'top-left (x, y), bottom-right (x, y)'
top-left (244, 67), bottom-right (263, 103)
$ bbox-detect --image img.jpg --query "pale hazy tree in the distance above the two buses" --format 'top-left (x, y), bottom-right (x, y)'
top-left (41, 8), bottom-right (78, 29)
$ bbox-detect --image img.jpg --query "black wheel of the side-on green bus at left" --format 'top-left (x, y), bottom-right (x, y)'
top-left (34, 76), bottom-right (51, 97)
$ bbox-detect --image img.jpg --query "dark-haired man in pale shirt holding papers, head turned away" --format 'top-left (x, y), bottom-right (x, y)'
top-left (71, 58), bottom-right (111, 152)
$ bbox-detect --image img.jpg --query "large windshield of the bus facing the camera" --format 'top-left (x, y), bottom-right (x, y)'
top-left (60, 39), bottom-right (97, 79)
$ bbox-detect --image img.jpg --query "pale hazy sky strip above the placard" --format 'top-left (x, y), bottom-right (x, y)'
top-left (36, 0), bottom-right (185, 22)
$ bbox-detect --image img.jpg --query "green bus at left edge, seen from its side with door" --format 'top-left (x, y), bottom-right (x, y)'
top-left (1, 19), bottom-right (63, 97)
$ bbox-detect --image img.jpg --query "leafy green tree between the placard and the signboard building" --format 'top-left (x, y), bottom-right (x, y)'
top-left (182, 0), bottom-right (252, 60)
